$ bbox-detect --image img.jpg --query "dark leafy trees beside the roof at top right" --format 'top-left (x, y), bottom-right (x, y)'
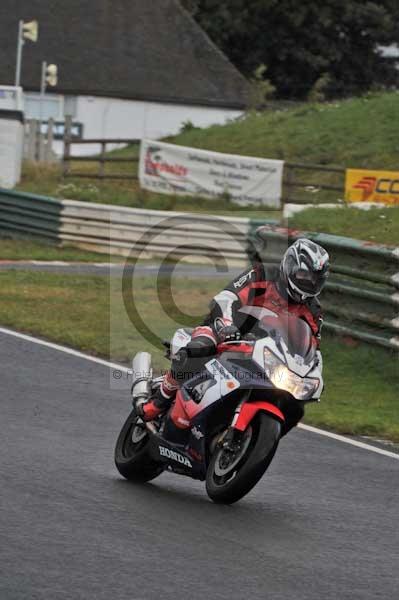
top-left (182, 0), bottom-right (399, 98)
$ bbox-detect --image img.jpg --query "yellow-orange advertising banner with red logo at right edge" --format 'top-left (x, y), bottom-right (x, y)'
top-left (345, 169), bottom-right (399, 205)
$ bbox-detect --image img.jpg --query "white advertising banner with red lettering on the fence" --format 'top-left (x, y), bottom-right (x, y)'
top-left (139, 140), bottom-right (284, 208)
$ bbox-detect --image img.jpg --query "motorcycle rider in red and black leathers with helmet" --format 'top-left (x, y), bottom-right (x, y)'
top-left (136, 238), bottom-right (329, 421)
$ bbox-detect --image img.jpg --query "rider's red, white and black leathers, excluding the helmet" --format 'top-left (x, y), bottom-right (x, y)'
top-left (143, 263), bottom-right (323, 419)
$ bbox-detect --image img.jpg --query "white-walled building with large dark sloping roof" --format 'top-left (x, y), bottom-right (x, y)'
top-left (0, 0), bottom-right (248, 153)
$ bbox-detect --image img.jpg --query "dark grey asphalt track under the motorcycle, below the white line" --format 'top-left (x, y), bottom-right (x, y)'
top-left (0, 333), bottom-right (399, 600)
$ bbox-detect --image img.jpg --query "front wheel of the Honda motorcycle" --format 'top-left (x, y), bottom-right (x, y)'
top-left (206, 412), bottom-right (281, 504)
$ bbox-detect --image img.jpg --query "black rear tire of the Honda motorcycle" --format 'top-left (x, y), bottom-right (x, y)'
top-left (115, 410), bottom-right (163, 483)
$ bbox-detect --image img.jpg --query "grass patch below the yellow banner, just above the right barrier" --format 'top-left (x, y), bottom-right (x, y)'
top-left (288, 206), bottom-right (399, 246)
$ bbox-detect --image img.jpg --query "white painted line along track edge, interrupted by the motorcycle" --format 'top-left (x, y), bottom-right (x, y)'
top-left (0, 327), bottom-right (399, 460)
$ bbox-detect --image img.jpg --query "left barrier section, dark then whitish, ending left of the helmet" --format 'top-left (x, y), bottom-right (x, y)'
top-left (0, 190), bottom-right (250, 266)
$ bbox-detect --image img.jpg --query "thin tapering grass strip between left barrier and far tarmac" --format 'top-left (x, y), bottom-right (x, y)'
top-left (0, 237), bottom-right (117, 262)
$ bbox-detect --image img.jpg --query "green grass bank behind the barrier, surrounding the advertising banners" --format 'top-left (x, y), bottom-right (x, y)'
top-left (14, 92), bottom-right (399, 244)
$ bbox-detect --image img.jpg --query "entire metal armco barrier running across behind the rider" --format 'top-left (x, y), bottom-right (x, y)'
top-left (0, 190), bottom-right (399, 351)
